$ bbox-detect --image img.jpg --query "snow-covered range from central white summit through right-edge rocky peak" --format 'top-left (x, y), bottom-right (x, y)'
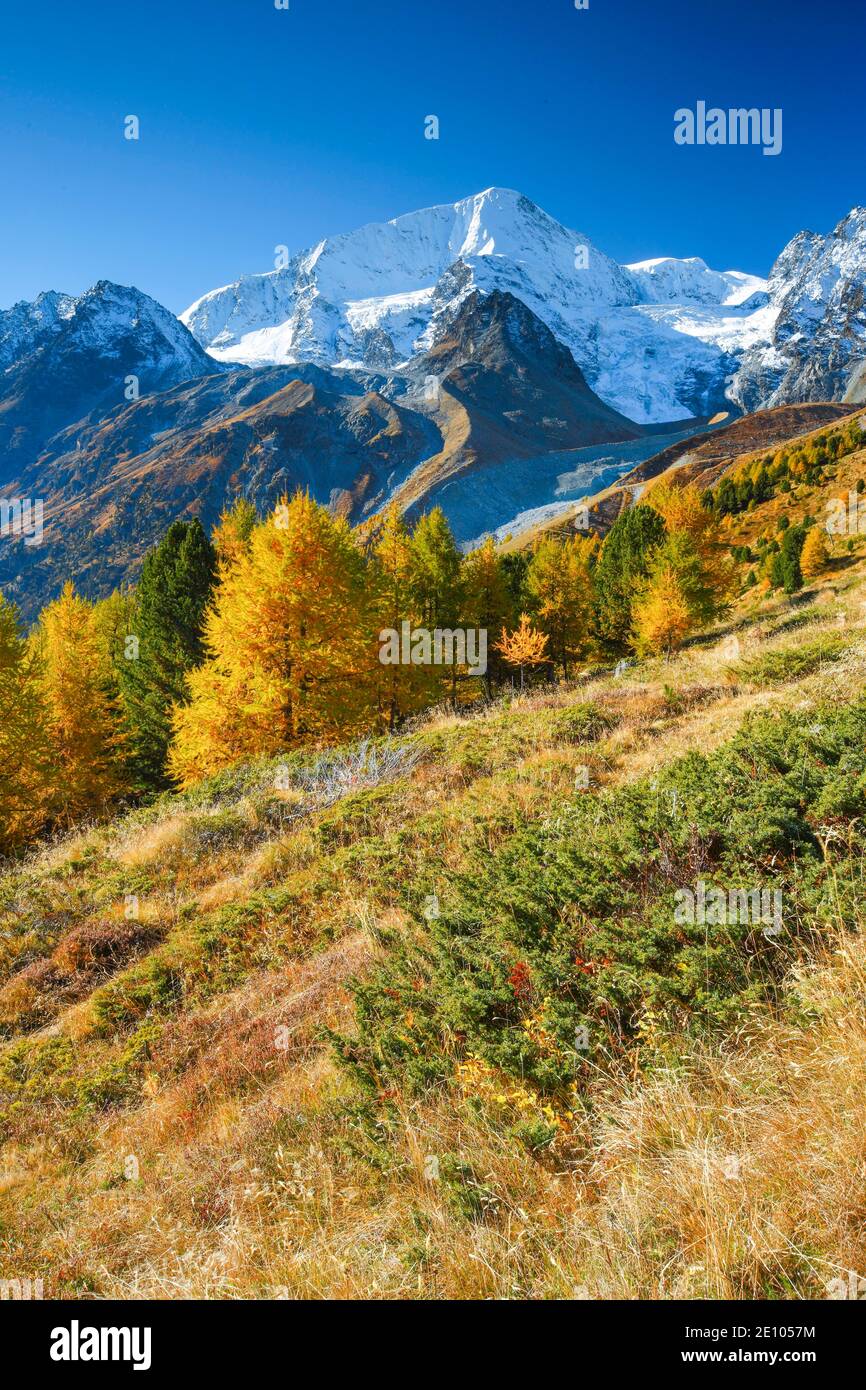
top-left (181, 188), bottom-right (866, 423)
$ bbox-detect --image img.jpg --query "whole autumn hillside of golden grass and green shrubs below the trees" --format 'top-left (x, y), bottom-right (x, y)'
top-left (0, 517), bottom-right (866, 1298)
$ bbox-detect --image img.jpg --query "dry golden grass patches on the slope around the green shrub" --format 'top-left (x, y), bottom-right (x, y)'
top-left (0, 550), bottom-right (866, 1300)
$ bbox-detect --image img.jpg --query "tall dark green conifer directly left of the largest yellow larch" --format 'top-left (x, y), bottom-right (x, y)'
top-left (118, 520), bottom-right (217, 790)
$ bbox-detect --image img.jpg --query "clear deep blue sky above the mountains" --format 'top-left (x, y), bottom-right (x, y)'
top-left (0, 0), bottom-right (866, 311)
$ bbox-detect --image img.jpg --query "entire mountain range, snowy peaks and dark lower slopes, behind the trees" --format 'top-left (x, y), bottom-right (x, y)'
top-left (0, 188), bottom-right (866, 617)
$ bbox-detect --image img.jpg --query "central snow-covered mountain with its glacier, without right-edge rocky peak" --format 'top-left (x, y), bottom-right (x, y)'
top-left (181, 188), bottom-right (766, 421)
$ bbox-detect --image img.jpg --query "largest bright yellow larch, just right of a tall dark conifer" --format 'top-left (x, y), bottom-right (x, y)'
top-left (170, 492), bottom-right (373, 785)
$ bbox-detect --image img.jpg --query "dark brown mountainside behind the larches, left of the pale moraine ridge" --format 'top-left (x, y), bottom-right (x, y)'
top-left (0, 367), bottom-right (439, 617)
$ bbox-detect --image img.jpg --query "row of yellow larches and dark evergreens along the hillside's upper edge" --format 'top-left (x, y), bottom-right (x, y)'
top-left (0, 484), bottom-right (735, 852)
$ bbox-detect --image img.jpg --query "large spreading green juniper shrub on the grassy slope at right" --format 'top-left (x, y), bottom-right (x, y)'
top-left (334, 703), bottom-right (866, 1099)
